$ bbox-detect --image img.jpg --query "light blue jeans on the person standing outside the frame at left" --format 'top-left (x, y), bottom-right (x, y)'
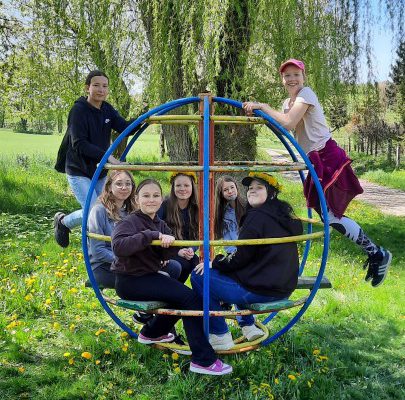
top-left (63, 175), bottom-right (107, 229)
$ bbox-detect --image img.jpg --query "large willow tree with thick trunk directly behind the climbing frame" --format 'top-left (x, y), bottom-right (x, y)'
top-left (139, 0), bottom-right (362, 159)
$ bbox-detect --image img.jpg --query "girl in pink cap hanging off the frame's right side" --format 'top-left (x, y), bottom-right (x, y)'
top-left (243, 58), bottom-right (392, 287)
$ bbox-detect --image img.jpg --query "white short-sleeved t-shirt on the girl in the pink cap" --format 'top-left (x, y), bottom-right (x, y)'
top-left (283, 87), bottom-right (332, 154)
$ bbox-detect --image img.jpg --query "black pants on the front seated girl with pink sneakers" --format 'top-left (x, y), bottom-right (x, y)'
top-left (115, 273), bottom-right (217, 367)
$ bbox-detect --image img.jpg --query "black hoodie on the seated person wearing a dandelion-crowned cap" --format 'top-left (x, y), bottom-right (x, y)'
top-left (212, 201), bottom-right (303, 298)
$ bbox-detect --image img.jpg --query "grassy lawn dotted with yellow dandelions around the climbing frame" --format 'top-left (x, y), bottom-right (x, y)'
top-left (0, 130), bottom-right (405, 400)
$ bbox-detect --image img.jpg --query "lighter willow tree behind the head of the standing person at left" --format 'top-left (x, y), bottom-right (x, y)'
top-left (15, 0), bottom-right (143, 151)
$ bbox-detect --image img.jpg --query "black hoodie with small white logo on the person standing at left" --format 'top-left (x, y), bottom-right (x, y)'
top-left (62, 97), bottom-right (130, 179)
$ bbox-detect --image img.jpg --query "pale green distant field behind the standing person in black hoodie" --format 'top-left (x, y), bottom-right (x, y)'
top-left (0, 129), bottom-right (159, 158)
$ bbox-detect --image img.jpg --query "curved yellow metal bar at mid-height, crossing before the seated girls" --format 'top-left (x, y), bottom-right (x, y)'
top-left (87, 228), bottom-right (330, 247)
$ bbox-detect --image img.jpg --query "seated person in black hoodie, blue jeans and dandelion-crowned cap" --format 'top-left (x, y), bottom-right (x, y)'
top-left (191, 172), bottom-right (303, 350)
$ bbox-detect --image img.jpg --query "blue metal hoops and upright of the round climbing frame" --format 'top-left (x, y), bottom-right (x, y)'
top-left (82, 95), bottom-right (329, 346)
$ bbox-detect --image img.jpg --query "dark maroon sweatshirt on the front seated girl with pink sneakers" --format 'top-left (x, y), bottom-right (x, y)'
top-left (111, 210), bottom-right (178, 276)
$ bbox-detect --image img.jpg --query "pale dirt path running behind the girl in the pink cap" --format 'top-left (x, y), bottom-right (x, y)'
top-left (267, 149), bottom-right (405, 217)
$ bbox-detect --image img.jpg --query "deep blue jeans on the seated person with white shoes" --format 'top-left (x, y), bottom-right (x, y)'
top-left (191, 269), bottom-right (280, 335)
